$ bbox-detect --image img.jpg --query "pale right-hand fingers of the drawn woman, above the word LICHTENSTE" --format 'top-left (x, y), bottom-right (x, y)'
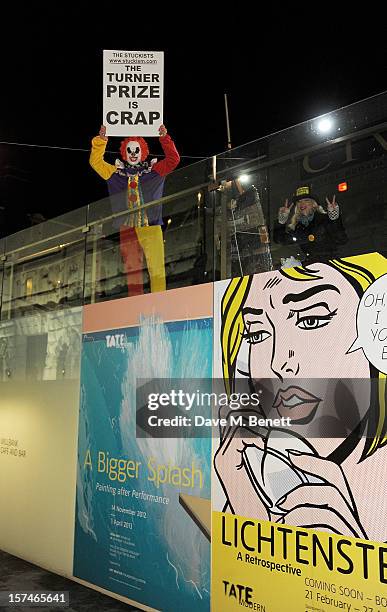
top-left (277, 451), bottom-right (367, 538)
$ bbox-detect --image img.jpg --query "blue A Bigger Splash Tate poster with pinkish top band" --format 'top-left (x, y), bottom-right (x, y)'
top-left (74, 284), bottom-right (213, 612)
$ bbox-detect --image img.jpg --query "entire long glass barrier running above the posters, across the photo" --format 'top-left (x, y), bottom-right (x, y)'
top-left (0, 93), bottom-right (387, 322)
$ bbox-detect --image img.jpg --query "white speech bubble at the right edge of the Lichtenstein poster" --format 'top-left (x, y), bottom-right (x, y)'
top-left (347, 274), bottom-right (387, 374)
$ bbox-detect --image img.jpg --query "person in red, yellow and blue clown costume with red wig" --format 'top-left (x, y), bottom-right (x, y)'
top-left (90, 125), bottom-right (180, 296)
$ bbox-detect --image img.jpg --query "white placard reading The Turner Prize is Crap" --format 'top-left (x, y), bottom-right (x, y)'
top-left (102, 51), bottom-right (164, 136)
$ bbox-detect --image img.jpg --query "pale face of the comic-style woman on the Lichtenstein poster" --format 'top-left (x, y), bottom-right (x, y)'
top-left (241, 264), bottom-right (370, 450)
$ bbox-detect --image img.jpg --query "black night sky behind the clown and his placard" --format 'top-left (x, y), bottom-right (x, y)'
top-left (0, 9), bottom-right (387, 235)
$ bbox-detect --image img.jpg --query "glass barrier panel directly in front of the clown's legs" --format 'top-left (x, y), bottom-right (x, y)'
top-left (84, 187), bottom-right (213, 303)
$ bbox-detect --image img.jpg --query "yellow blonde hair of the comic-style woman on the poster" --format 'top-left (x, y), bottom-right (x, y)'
top-left (221, 253), bottom-right (387, 460)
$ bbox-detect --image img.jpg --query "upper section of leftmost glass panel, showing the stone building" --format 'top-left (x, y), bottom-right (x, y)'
top-left (1, 208), bottom-right (87, 321)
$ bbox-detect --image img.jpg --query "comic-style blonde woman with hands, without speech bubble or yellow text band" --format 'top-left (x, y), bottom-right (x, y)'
top-left (214, 253), bottom-right (387, 542)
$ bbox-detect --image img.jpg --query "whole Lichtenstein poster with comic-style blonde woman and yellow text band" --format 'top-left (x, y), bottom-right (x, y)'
top-left (211, 253), bottom-right (387, 612)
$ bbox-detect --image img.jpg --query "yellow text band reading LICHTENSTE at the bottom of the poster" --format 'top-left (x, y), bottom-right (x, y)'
top-left (212, 509), bottom-right (387, 612)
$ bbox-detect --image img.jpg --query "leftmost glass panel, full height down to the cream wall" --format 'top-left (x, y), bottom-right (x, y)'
top-left (0, 208), bottom-right (86, 382)
